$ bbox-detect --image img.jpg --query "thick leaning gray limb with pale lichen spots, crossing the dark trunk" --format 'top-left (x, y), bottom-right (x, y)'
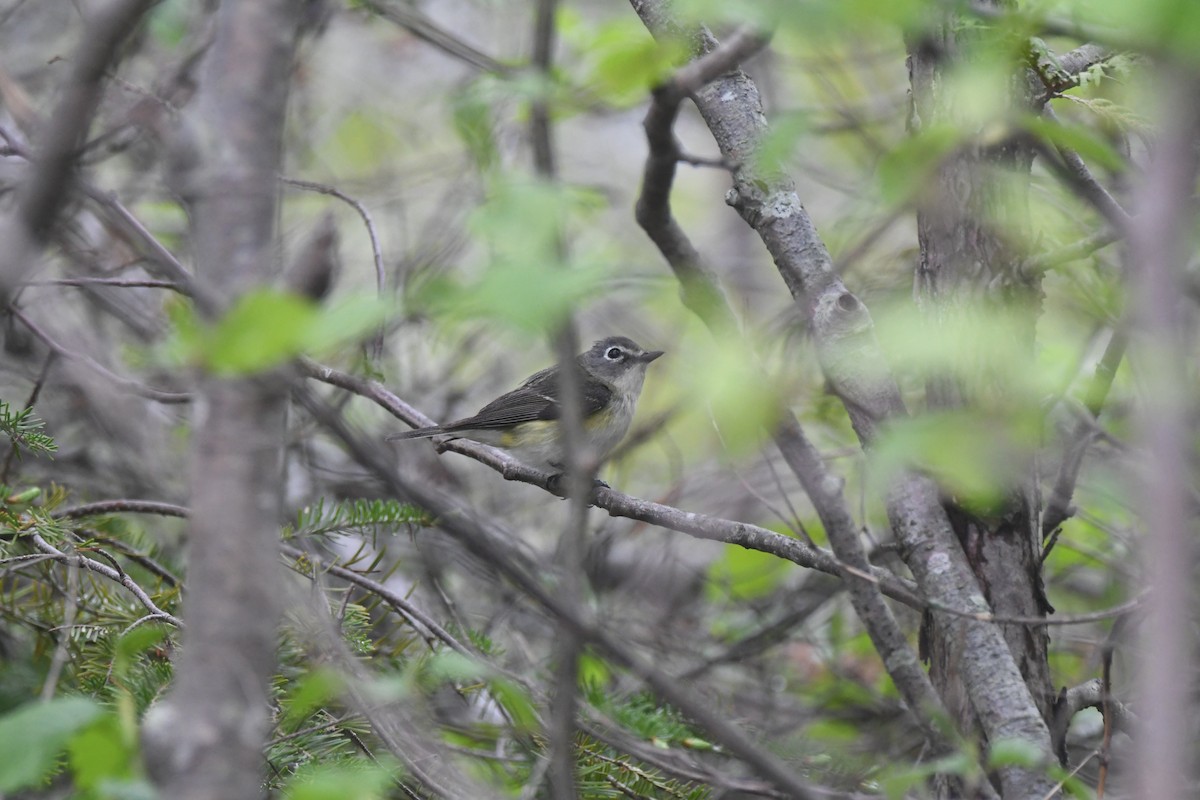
top-left (631, 0), bottom-right (1052, 794)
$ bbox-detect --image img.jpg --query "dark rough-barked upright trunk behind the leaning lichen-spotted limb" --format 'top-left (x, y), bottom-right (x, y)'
top-left (908, 7), bottom-right (1054, 782)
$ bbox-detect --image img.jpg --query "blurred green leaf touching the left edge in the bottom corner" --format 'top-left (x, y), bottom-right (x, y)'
top-left (0, 697), bottom-right (101, 792)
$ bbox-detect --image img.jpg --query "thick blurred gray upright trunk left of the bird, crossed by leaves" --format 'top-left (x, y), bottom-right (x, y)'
top-left (145, 0), bottom-right (298, 800)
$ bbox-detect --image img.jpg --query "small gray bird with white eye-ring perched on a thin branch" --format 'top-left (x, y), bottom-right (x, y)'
top-left (385, 336), bottom-right (662, 473)
